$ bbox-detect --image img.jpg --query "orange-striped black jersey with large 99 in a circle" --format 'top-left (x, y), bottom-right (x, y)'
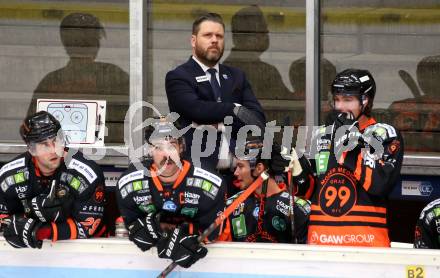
top-left (297, 118), bottom-right (403, 246)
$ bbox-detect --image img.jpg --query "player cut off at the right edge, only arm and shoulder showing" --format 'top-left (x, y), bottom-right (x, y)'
top-left (414, 199), bottom-right (440, 249)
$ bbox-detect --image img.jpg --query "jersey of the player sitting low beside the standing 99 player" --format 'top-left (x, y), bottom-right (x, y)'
top-left (221, 190), bottom-right (310, 243)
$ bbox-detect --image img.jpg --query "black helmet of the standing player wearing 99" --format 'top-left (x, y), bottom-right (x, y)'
top-left (332, 69), bottom-right (376, 100)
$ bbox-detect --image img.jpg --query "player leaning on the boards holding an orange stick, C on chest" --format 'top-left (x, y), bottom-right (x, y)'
top-left (116, 118), bottom-right (226, 267)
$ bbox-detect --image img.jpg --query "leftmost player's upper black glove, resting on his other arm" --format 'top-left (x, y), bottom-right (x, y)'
top-left (29, 189), bottom-right (73, 222)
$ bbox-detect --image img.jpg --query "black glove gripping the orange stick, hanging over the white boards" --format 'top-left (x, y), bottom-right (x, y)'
top-left (157, 223), bottom-right (208, 268)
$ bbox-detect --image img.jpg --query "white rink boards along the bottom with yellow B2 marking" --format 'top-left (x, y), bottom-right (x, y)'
top-left (0, 238), bottom-right (440, 278)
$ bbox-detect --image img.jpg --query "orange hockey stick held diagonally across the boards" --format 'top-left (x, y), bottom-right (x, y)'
top-left (157, 172), bottom-right (269, 278)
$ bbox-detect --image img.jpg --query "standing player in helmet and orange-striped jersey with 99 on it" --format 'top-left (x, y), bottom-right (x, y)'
top-left (293, 69), bottom-right (403, 247)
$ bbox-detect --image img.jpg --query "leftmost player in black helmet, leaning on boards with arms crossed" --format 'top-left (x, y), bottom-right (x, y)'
top-left (0, 111), bottom-right (105, 248)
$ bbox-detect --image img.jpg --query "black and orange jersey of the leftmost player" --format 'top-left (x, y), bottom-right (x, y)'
top-left (0, 151), bottom-right (105, 241)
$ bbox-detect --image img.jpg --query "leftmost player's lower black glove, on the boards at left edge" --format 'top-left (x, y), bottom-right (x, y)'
top-left (3, 214), bottom-right (43, 249)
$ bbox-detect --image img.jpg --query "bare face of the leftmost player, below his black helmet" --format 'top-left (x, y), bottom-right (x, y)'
top-left (30, 137), bottom-right (64, 175)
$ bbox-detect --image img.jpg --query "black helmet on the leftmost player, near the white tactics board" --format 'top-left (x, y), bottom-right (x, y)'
top-left (20, 111), bottom-right (61, 144)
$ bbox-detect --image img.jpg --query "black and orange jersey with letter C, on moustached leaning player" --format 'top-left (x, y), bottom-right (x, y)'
top-left (116, 160), bottom-right (226, 240)
